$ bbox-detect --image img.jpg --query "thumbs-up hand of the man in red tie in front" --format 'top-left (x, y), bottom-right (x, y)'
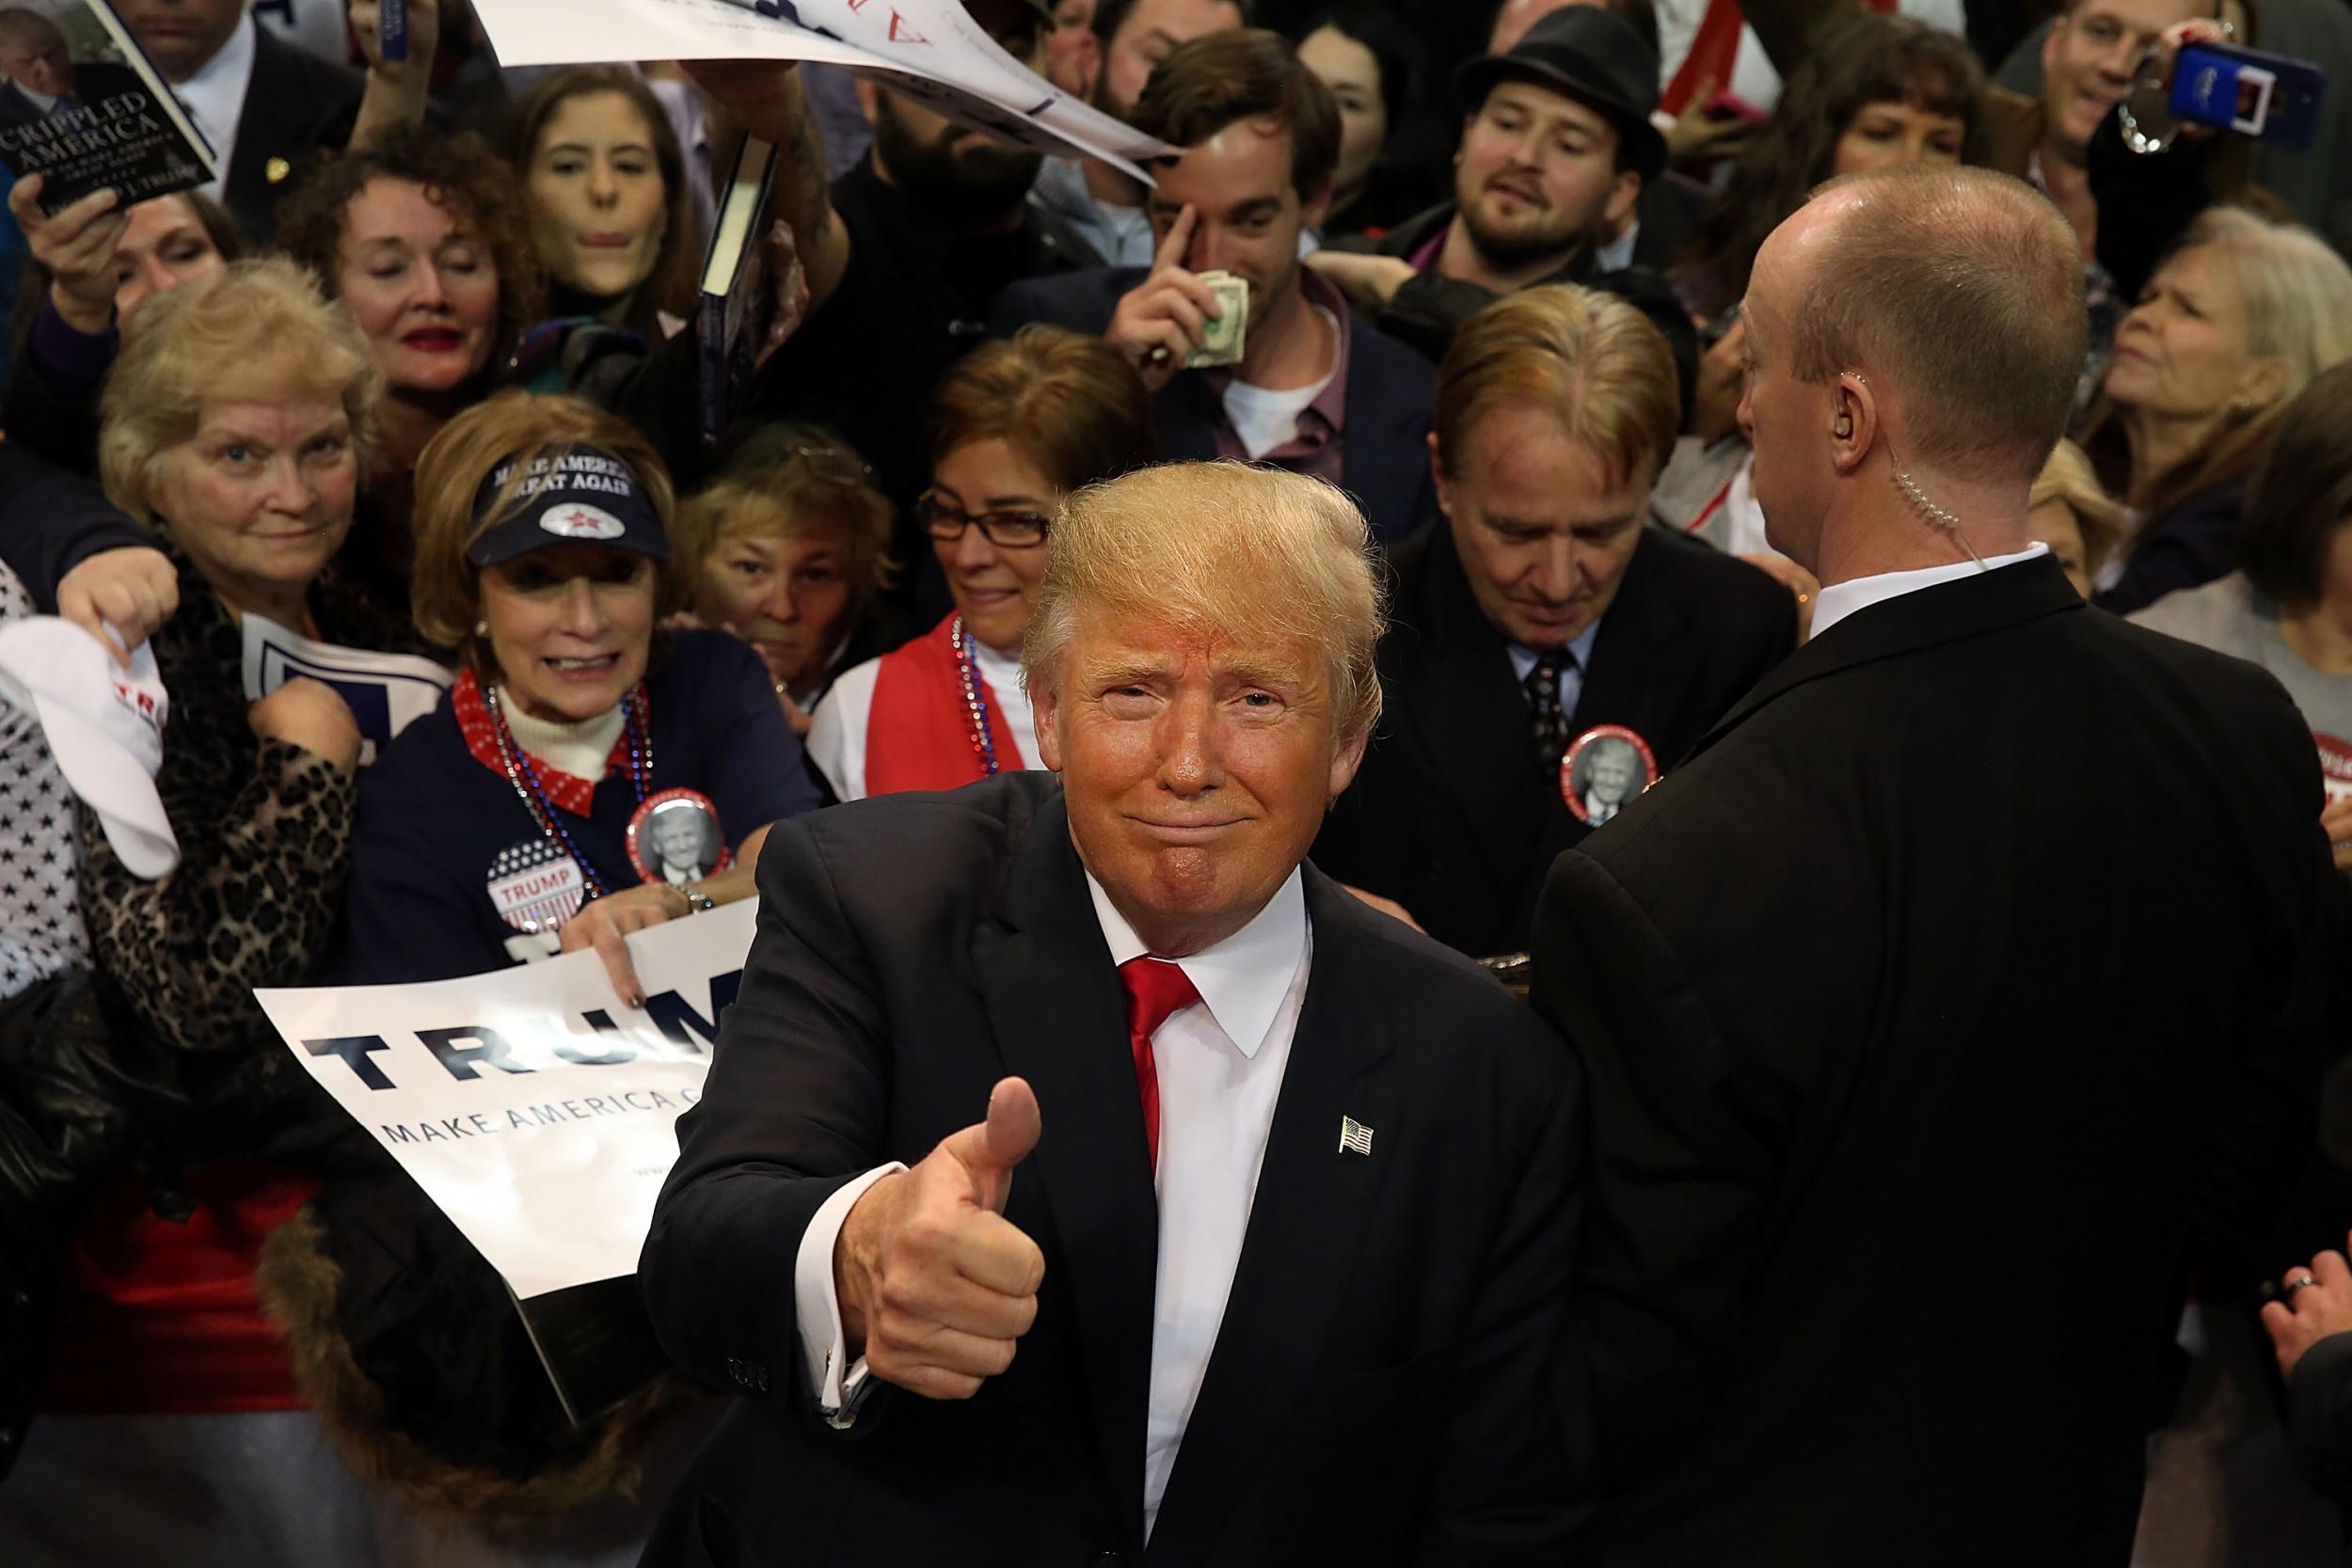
top-left (833, 1079), bottom-right (1044, 1399)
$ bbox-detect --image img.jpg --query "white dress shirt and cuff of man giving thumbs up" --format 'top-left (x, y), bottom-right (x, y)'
top-left (793, 870), bottom-right (1315, 1535)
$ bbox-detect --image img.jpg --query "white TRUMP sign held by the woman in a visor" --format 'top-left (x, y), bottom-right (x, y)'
top-left (254, 898), bottom-right (760, 1300)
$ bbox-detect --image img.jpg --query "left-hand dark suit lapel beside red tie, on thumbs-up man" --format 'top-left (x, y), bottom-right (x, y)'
top-left (974, 790), bottom-right (1160, 1552)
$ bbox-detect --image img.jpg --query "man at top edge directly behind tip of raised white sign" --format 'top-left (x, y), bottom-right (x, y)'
top-left (1030, 0), bottom-right (1249, 265)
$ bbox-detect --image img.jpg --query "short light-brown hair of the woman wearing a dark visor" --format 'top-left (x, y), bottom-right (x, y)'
top-left (409, 388), bottom-right (687, 677)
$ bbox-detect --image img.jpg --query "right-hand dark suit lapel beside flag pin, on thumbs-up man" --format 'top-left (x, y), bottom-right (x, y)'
top-left (1148, 867), bottom-right (1409, 1568)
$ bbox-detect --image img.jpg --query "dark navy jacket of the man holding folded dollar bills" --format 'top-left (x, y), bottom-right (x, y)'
top-left (988, 268), bottom-right (1438, 541)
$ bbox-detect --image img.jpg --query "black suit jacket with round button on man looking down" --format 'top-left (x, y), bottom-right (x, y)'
top-left (1315, 517), bottom-right (1797, 957)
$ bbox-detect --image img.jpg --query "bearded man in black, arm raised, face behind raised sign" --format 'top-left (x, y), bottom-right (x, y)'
top-left (696, 0), bottom-right (1099, 618)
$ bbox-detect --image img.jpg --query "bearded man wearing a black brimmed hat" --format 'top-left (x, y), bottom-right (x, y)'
top-left (1312, 5), bottom-right (1698, 399)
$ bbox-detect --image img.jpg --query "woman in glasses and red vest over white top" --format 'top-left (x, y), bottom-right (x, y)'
top-left (809, 325), bottom-right (1155, 801)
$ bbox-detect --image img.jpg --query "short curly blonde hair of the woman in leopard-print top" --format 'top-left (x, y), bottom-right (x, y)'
top-left (99, 256), bottom-right (384, 524)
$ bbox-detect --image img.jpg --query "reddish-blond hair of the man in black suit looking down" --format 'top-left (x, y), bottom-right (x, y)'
top-left (1433, 282), bottom-right (1682, 482)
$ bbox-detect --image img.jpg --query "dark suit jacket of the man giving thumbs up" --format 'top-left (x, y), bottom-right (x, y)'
top-left (643, 773), bottom-right (1583, 1568)
